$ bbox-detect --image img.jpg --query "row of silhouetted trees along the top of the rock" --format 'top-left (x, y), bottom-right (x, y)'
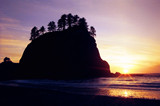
top-left (30, 13), bottom-right (96, 41)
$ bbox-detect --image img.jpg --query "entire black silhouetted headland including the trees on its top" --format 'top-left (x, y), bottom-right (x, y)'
top-left (0, 13), bottom-right (113, 79)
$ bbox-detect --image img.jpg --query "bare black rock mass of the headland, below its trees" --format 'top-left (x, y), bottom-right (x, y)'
top-left (20, 28), bottom-right (110, 79)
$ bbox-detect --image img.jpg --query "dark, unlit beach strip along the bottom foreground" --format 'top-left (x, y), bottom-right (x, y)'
top-left (0, 86), bottom-right (160, 106)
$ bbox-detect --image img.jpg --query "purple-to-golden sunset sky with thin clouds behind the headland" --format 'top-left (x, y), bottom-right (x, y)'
top-left (0, 0), bottom-right (160, 73)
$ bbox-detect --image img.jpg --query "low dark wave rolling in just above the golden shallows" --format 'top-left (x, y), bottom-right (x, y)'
top-left (0, 80), bottom-right (160, 91)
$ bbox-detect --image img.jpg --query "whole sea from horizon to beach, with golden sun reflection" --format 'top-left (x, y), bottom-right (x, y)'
top-left (0, 74), bottom-right (160, 100)
